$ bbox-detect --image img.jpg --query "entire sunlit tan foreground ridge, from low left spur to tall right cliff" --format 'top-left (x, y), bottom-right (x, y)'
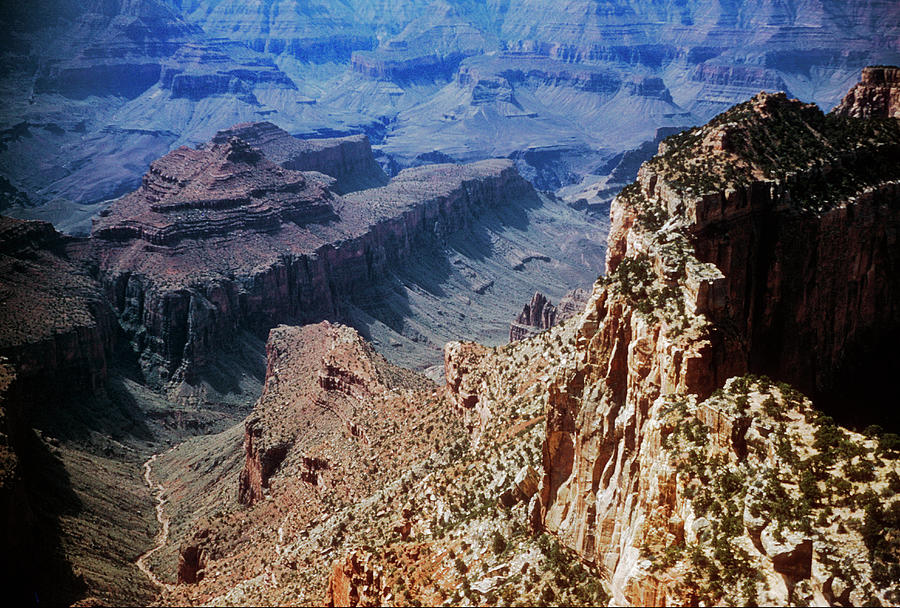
top-left (38, 69), bottom-right (888, 605)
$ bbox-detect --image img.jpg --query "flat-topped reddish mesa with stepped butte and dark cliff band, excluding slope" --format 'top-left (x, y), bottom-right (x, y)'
top-left (91, 126), bottom-right (537, 382)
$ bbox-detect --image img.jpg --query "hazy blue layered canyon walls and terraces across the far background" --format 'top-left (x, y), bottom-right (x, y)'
top-left (0, 0), bottom-right (900, 230)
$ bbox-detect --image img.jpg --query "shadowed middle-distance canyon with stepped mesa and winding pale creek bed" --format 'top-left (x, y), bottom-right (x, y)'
top-left (0, 115), bottom-right (606, 603)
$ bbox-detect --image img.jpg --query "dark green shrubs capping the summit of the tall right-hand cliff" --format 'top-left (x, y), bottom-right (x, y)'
top-left (650, 96), bottom-right (900, 211)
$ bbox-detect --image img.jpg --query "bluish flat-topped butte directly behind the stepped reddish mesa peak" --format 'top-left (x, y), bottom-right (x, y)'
top-left (212, 122), bottom-right (388, 194)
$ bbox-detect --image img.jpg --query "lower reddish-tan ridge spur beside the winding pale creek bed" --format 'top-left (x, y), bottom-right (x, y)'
top-left (150, 321), bottom-right (464, 603)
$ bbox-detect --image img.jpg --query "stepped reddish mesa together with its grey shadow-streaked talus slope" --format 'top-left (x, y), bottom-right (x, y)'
top-left (87, 125), bottom-right (604, 392)
